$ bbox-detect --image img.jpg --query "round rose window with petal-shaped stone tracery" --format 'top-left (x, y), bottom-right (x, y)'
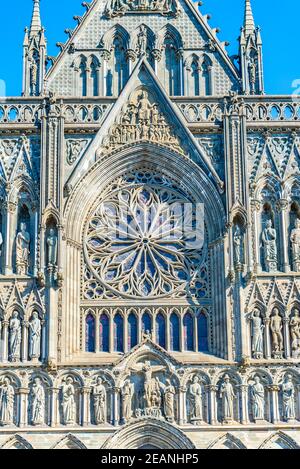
top-left (85, 185), bottom-right (204, 298)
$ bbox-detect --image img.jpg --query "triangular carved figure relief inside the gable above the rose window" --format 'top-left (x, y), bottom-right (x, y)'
top-left (99, 90), bottom-right (184, 154)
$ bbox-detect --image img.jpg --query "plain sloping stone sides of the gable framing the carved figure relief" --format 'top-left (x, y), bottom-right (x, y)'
top-left (67, 59), bottom-right (223, 190)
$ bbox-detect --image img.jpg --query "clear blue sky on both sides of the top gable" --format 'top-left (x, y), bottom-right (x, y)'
top-left (0, 0), bottom-right (300, 96)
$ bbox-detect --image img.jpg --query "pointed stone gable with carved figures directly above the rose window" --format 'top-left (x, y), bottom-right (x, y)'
top-left (67, 59), bottom-right (223, 191)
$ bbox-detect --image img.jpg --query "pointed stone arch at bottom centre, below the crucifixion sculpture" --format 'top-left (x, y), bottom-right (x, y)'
top-left (101, 419), bottom-right (195, 450)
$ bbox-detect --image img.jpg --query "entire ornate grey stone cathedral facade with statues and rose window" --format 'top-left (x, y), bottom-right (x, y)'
top-left (0, 0), bottom-right (300, 449)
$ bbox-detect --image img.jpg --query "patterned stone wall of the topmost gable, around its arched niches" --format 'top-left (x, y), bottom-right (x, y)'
top-left (47, 0), bottom-right (238, 96)
